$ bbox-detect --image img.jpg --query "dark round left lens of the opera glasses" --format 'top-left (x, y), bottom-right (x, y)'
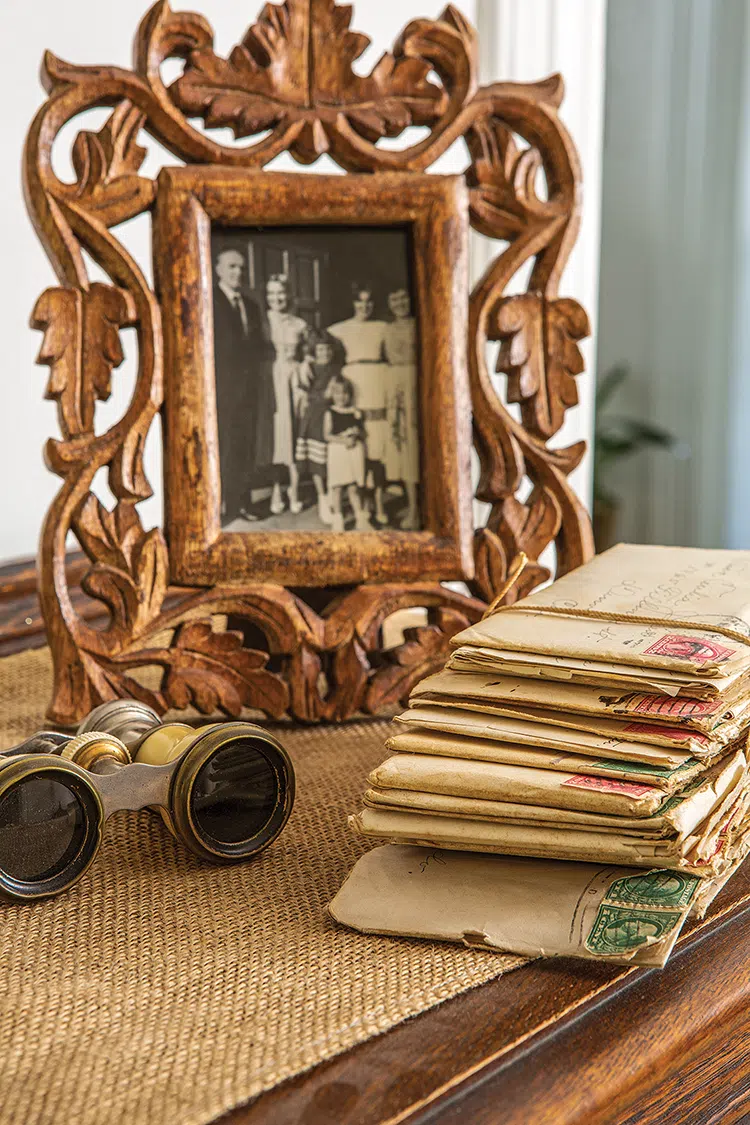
top-left (0, 777), bottom-right (85, 882)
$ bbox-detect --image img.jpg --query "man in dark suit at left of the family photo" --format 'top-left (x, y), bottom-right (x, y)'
top-left (214, 249), bottom-right (272, 525)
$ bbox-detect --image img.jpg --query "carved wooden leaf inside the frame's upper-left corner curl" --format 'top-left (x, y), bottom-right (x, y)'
top-left (72, 99), bottom-right (156, 226)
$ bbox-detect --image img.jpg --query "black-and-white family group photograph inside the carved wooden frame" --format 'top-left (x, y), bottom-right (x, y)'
top-left (211, 227), bottom-right (421, 531)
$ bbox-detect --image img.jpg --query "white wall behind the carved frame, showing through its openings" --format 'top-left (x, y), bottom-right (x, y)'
top-left (0, 0), bottom-right (606, 560)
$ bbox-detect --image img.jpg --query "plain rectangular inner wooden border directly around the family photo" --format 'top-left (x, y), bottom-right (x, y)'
top-left (154, 165), bottom-right (473, 587)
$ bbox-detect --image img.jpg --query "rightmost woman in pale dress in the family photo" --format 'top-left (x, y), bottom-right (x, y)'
top-left (385, 289), bottom-right (419, 529)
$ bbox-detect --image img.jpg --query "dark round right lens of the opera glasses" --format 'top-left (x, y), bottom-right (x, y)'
top-left (191, 738), bottom-right (279, 844)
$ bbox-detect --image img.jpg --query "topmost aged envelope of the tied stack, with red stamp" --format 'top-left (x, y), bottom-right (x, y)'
top-left (454, 545), bottom-right (750, 677)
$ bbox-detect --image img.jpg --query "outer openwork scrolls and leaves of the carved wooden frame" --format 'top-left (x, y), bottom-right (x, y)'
top-left (24, 0), bottom-right (593, 723)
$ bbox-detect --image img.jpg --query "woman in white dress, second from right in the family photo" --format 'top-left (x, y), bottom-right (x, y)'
top-left (328, 282), bottom-right (388, 527)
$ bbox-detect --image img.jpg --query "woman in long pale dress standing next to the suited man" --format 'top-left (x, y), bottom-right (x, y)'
top-left (265, 273), bottom-right (308, 515)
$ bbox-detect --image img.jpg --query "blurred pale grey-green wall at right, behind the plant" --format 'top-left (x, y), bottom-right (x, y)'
top-left (598, 0), bottom-right (750, 547)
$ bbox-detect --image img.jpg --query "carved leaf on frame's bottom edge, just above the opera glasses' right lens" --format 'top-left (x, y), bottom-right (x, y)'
top-left (164, 621), bottom-right (289, 719)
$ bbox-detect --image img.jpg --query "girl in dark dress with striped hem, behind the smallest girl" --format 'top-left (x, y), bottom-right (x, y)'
top-left (295, 332), bottom-right (341, 523)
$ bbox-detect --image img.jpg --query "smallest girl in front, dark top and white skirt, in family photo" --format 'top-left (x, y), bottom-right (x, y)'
top-left (323, 375), bottom-right (371, 531)
